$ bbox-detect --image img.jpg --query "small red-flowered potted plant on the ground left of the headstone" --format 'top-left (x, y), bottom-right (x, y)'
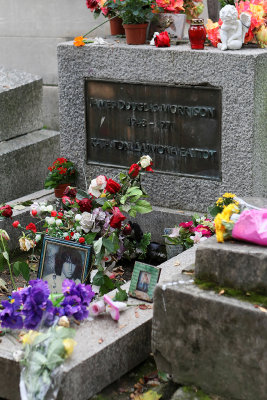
top-left (44, 157), bottom-right (77, 198)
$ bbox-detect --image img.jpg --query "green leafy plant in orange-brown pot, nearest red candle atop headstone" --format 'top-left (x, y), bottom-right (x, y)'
top-left (115, 0), bottom-right (156, 44)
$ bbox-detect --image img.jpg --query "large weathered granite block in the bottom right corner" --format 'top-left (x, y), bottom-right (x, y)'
top-left (152, 275), bottom-right (267, 400)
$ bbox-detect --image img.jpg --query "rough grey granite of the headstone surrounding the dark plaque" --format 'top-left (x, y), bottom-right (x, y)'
top-left (58, 40), bottom-right (267, 212)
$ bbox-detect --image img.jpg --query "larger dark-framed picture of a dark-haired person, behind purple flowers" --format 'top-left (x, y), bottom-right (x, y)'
top-left (38, 236), bottom-right (92, 293)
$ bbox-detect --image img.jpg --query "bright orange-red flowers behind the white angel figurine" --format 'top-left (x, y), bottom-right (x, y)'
top-left (206, 0), bottom-right (267, 48)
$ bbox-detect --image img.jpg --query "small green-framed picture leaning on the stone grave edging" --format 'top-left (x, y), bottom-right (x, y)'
top-left (129, 261), bottom-right (161, 302)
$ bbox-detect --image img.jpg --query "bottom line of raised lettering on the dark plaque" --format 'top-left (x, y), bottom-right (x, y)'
top-left (90, 138), bottom-right (217, 159)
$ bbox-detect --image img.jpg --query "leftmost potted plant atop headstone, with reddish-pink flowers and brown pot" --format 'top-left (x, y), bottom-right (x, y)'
top-left (86, 0), bottom-right (125, 35)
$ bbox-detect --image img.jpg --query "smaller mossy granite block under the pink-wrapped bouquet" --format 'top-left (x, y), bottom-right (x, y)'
top-left (195, 237), bottom-right (267, 294)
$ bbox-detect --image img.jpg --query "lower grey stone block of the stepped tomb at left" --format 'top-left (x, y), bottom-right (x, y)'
top-left (0, 129), bottom-right (60, 203)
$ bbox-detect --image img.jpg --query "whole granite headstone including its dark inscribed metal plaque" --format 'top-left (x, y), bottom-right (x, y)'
top-left (58, 39), bottom-right (267, 216)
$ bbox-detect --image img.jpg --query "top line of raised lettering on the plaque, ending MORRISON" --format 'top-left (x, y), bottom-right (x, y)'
top-left (89, 97), bottom-right (216, 118)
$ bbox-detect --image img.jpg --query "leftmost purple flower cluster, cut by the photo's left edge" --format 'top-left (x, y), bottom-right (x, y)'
top-left (0, 292), bottom-right (23, 329)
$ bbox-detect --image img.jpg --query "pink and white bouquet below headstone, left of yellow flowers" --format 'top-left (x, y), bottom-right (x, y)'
top-left (163, 215), bottom-right (215, 250)
